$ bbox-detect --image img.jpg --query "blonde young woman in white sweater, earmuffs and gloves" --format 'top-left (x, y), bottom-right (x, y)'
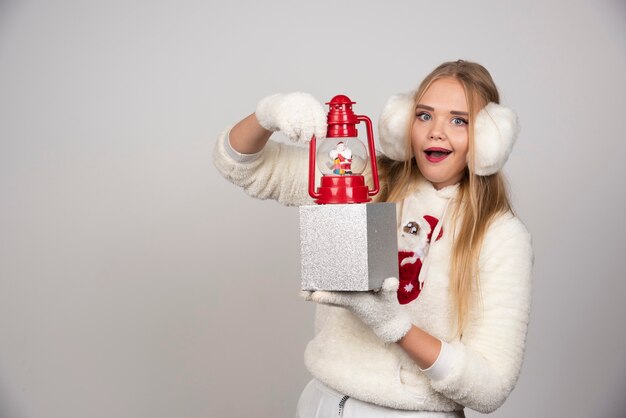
top-left (214, 61), bottom-right (532, 418)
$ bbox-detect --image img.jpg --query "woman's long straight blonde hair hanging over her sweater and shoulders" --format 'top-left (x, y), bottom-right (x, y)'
top-left (378, 60), bottom-right (512, 335)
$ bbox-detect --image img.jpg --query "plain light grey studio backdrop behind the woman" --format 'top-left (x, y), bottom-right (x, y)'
top-left (0, 0), bottom-right (626, 418)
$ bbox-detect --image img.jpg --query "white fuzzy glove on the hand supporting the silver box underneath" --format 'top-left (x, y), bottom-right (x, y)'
top-left (303, 277), bottom-right (411, 343)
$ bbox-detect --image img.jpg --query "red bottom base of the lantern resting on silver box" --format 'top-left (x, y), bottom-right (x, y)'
top-left (315, 175), bottom-right (372, 205)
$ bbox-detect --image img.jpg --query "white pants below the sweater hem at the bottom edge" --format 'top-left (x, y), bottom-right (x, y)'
top-left (296, 379), bottom-right (465, 418)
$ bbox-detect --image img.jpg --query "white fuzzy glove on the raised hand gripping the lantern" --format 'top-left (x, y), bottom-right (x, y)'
top-left (255, 92), bottom-right (327, 143)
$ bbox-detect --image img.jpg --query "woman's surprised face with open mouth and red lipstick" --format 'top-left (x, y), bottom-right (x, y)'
top-left (411, 78), bottom-right (469, 189)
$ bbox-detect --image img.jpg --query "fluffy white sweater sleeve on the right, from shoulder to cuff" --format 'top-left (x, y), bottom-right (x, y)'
top-left (418, 214), bottom-right (533, 413)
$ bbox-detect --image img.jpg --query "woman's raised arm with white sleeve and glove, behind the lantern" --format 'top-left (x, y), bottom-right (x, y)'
top-left (213, 93), bottom-right (326, 206)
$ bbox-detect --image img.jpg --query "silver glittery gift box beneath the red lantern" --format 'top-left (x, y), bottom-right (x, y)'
top-left (300, 203), bottom-right (398, 291)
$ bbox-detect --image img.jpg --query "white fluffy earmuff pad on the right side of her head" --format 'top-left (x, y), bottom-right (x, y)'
top-left (468, 102), bottom-right (520, 176)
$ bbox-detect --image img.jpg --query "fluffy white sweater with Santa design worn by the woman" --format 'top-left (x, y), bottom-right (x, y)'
top-left (214, 132), bottom-right (533, 412)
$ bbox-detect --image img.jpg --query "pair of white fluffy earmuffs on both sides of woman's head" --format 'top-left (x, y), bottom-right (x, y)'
top-left (378, 91), bottom-right (519, 176)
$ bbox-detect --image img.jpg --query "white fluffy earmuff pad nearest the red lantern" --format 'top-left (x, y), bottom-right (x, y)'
top-left (378, 91), bottom-right (415, 161)
